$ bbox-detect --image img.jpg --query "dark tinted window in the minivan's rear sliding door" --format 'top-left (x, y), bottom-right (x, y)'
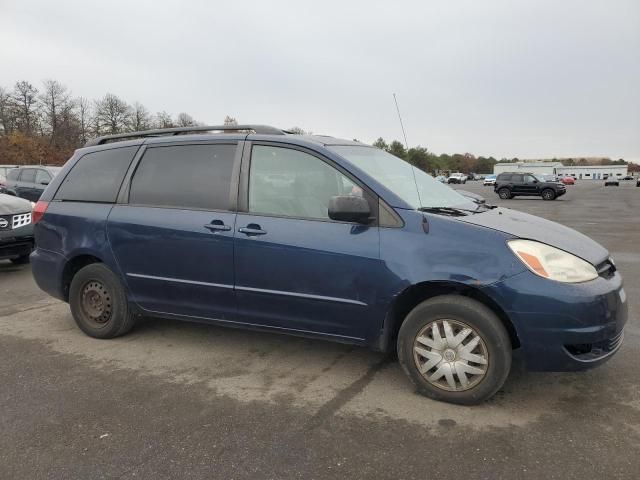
top-left (129, 145), bottom-right (236, 210)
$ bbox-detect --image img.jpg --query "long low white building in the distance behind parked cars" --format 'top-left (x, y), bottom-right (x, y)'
top-left (493, 162), bottom-right (628, 180)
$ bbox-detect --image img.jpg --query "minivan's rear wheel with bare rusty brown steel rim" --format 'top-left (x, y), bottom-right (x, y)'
top-left (69, 263), bottom-right (135, 338)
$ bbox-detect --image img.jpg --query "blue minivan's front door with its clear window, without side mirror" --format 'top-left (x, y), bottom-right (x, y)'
top-left (235, 144), bottom-right (385, 340)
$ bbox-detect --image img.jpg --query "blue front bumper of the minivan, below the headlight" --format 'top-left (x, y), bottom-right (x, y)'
top-left (487, 271), bottom-right (628, 371)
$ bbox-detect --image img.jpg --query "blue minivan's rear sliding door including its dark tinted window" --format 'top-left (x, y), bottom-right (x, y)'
top-left (108, 143), bottom-right (240, 320)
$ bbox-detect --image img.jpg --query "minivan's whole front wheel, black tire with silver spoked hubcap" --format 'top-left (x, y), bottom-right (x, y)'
top-left (397, 295), bottom-right (511, 405)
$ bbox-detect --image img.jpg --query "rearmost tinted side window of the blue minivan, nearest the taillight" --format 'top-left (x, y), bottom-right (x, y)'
top-left (55, 146), bottom-right (138, 203)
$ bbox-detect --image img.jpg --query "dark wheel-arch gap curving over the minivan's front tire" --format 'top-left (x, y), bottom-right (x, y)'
top-left (379, 281), bottom-right (521, 351)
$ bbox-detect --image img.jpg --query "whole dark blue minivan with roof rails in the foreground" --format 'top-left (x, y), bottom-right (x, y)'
top-left (31, 125), bottom-right (627, 404)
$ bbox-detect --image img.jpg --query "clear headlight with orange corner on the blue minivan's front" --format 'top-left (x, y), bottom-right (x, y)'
top-left (507, 240), bottom-right (598, 283)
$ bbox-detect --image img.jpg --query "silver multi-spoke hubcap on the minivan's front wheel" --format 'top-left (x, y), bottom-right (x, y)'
top-left (413, 320), bottom-right (489, 392)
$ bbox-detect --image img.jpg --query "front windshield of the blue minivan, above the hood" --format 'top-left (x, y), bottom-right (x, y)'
top-left (328, 145), bottom-right (477, 209)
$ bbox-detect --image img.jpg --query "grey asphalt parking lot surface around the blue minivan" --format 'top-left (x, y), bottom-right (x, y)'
top-left (0, 181), bottom-right (640, 479)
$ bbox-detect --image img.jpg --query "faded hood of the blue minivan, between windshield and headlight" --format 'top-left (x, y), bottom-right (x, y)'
top-left (456, 208), bottom-right (609, 266)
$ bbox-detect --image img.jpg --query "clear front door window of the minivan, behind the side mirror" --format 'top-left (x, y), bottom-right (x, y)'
top-left (249, 145), bottom-right (362, 220)
